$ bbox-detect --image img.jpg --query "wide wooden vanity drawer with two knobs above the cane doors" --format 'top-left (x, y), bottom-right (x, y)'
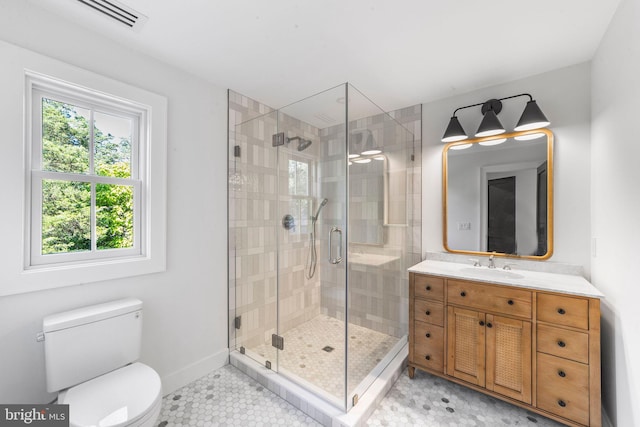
top-left (447, 279), bottom-right (532, 319)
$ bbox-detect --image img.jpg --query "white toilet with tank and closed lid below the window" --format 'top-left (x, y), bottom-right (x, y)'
top-left (42, 298), bottom-right (162, 427)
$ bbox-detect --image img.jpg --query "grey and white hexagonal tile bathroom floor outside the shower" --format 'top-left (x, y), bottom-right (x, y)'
top-left (157, 365), bottom-right (561, 427)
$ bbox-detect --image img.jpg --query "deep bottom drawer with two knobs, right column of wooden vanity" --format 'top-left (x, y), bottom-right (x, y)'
top-left (537, 353), bottom-right (589, 425)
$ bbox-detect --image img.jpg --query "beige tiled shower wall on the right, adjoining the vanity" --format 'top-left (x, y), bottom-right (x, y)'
top-left (321, 105), bottom-right (422, 338)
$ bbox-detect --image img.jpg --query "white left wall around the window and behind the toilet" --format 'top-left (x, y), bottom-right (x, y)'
top-left (0, 1), bottom-right (228, 403)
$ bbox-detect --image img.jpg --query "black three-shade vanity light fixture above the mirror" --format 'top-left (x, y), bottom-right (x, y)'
top-left (442, 93), bottom-right (550, 143)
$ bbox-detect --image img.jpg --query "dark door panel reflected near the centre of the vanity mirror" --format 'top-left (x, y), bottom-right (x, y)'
top-left (487, 176), bottom-right (516, 254)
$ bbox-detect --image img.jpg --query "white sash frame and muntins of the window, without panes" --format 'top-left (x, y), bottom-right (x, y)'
top-left (24, 72), bottom-right (145, 269)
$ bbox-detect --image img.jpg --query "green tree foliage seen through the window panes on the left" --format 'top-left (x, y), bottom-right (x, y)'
top-left (42, 98), bottom-right (134, 254)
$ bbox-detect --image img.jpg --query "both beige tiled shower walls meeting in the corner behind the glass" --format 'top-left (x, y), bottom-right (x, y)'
top-left (229, 91), bottom-right (421, 348)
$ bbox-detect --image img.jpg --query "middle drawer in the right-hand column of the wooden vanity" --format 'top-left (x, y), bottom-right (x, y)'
top-left (537, 324), bottom-right (589, 363)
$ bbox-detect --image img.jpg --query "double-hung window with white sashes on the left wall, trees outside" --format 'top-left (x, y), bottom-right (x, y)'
top-left (25, 74), bottom-right (166, 284)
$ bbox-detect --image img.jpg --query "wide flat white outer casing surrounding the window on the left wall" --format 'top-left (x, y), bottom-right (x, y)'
top-left (0, 57), bottom-right (167, 296)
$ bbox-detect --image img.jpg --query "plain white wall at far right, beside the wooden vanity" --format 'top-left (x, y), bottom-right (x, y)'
top-left (591, 0), bottom-right (640, 426)
